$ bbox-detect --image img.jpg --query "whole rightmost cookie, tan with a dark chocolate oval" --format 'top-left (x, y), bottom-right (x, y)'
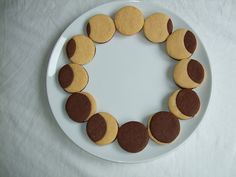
top-left (173, 59), bottom-right (204, 88)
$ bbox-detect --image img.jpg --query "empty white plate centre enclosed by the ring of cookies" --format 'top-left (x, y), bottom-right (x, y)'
top-left (85, 32), bottom-right (176, 123)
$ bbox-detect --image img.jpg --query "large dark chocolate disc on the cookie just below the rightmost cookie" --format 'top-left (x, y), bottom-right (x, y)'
top-left (176, 89), bottom-right (200, 117)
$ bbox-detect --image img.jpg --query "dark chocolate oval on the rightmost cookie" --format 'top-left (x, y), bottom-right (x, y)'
top-left (187, 59), bottom-right (204, 84)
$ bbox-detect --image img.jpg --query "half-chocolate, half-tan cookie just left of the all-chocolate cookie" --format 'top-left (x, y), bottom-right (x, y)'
top-left (86, 112), bottom-right (118, 145)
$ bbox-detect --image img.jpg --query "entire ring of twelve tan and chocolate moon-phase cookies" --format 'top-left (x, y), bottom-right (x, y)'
top-left (58, 6), bottom-right (205, 153)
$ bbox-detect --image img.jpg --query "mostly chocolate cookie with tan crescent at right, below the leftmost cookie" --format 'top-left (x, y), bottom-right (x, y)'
top-left (65, 92), bottom-right (96, 123)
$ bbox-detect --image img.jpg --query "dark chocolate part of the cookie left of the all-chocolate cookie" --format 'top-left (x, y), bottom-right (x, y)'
top-left (86, 113), bottom-right (107, 142)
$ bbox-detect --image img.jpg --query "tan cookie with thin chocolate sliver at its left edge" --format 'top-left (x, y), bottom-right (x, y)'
top-left (87, 14), bottom-right (116, 43)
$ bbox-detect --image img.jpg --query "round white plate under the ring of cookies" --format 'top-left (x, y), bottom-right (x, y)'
top-left (46, 1), bottom-right (211, 163)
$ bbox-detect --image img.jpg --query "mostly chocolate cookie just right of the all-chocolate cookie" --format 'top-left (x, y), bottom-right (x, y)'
top-left (148, 111), bottom-right (180, 144)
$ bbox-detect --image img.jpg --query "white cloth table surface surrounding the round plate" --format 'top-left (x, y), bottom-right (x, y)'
top-left (0, 0), bottom-right (236, 177)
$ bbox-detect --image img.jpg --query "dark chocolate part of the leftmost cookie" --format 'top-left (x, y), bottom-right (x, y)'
top-left (58, 65), bottom-right (74, 88)
